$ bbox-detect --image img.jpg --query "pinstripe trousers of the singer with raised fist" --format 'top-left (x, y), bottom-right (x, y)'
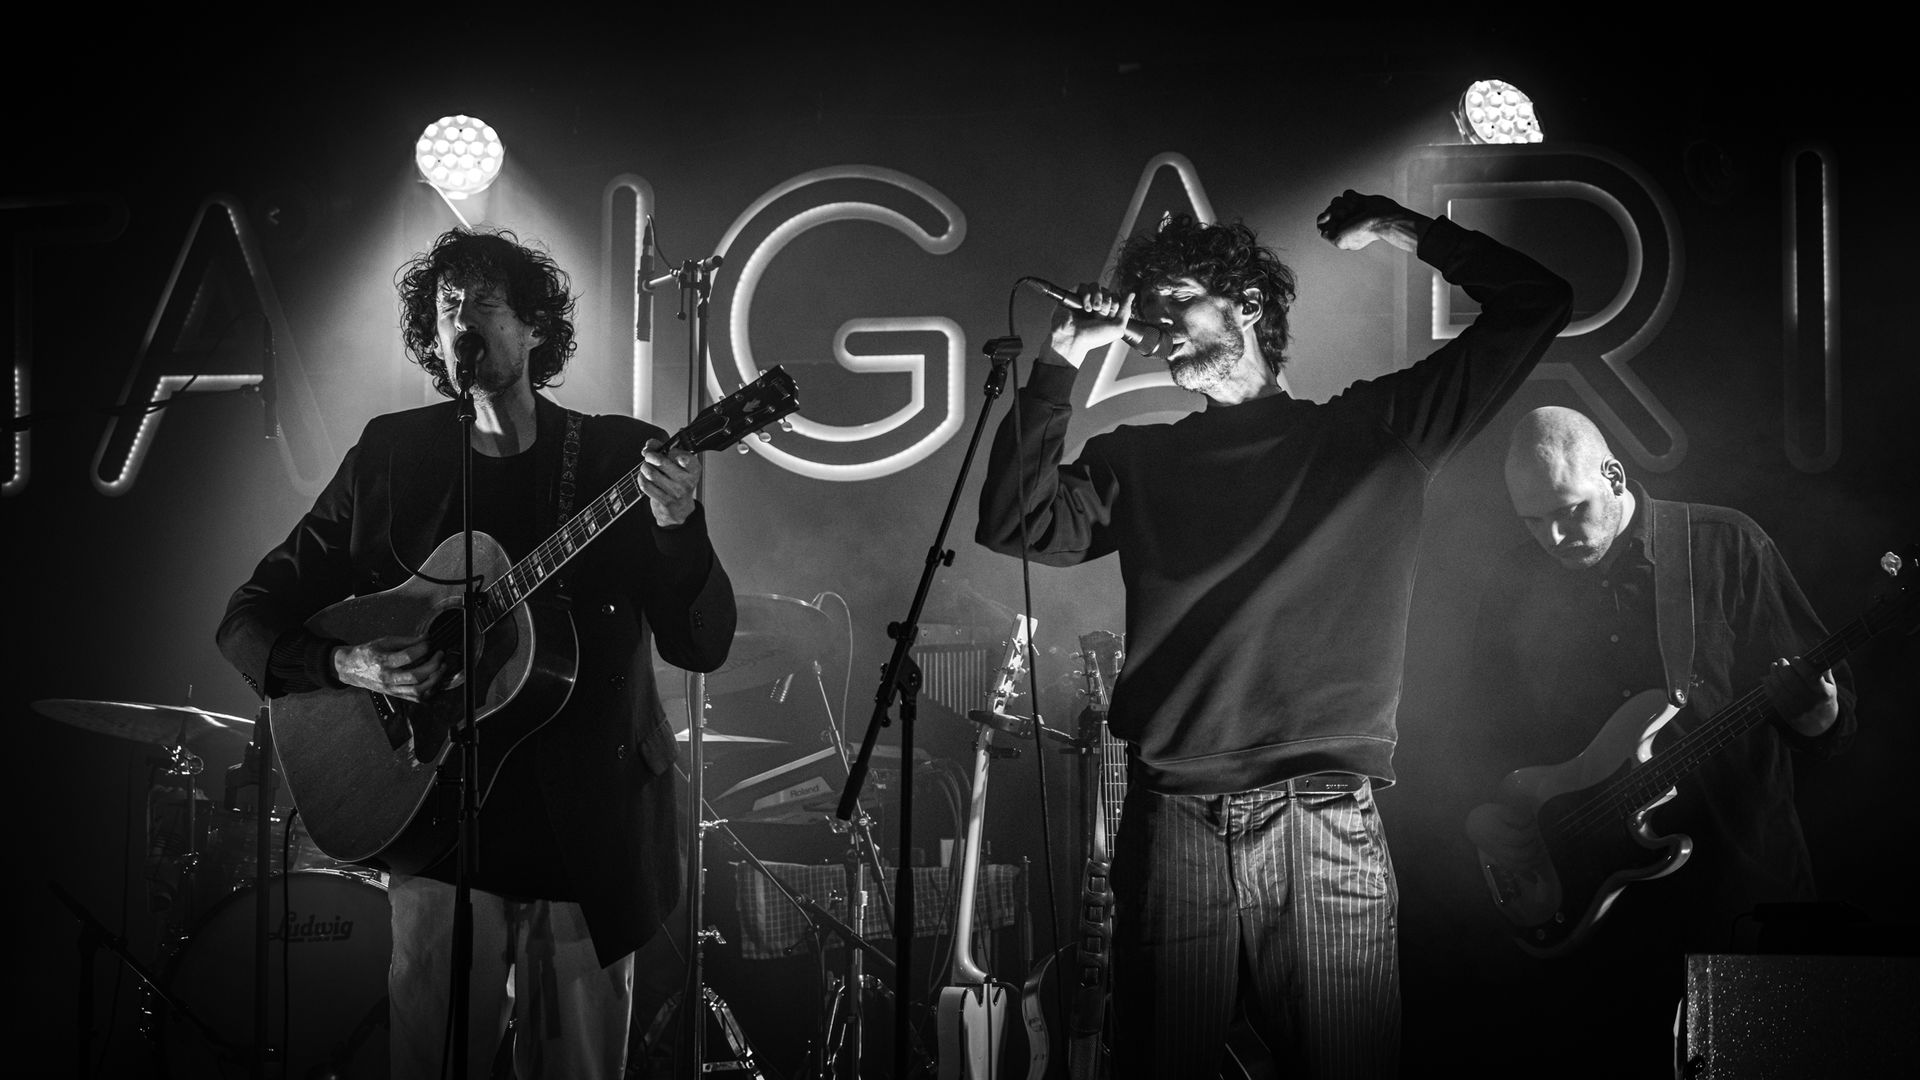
top-left (1114, 784), bottom-right (1400, 1078)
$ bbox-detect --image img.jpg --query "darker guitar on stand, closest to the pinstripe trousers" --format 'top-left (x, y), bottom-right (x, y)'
top-left (1068, 630), bottom-right (1127, 1080)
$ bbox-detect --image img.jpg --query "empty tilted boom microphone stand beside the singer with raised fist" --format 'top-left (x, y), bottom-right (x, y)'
top-left (837, 336), bottom-right (1021, 1080)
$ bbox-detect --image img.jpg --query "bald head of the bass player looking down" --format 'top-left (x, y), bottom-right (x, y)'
top-left (1507, 405), bottom-right (1634, 569)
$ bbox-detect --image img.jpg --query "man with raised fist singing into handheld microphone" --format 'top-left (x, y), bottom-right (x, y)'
top-left (977, 192), bottom-right (1571, 1078)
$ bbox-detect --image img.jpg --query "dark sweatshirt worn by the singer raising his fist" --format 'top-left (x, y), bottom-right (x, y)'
top-left (977, 219), bottom-right (1571, 794)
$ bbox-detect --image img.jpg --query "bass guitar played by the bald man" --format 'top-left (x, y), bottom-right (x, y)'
top-left (1467, 546), bottom-right (1920, 957)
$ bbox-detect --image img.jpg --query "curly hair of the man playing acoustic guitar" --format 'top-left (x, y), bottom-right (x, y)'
top-left (394, 229), bottom-right (578, 398)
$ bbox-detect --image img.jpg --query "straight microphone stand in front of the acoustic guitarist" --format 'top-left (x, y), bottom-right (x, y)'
top-left (451, 355), bottom-right (480, 1076)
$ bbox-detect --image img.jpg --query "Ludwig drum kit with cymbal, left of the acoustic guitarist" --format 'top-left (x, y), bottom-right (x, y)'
top-left (33, 698), bottom-right (392, 1078)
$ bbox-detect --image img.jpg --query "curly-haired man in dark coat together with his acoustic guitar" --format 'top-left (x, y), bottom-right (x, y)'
top-left (219, 231), bottom-right (735, 1080)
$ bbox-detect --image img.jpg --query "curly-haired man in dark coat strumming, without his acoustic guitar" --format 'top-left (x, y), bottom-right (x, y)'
top-left (219, 222), bottom-right (735, 1080)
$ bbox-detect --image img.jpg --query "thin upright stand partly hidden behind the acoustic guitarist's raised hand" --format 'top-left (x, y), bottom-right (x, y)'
top-left (639, 249), bottom-right (726, 1080)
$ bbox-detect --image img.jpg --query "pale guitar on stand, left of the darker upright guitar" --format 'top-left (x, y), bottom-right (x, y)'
top-left (937, 615), bottom-right (1035, 1080)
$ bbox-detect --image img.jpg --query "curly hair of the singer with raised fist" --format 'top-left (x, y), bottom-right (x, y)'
top-left (1116, 213), bottom-right (1294, 375)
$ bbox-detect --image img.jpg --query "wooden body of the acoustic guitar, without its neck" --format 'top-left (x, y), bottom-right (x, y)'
top-left (271, 532), bottom-right (578, 872)
